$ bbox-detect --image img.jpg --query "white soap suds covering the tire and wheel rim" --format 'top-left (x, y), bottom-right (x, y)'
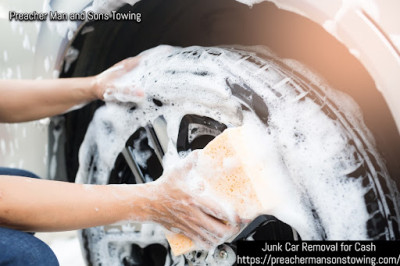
top-left (3, 0), bottom-right (398, 262)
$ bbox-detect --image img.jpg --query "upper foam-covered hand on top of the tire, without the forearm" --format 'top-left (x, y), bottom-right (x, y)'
top-left (93, 56), bottom-right (144, 102)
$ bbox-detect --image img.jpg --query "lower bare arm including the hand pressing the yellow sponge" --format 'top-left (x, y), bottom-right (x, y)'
top-left (0, 154), bottom-right (238, 245)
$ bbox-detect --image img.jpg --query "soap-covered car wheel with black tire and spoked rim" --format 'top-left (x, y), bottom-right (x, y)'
top-left (72, 46), bottom-right (399, 265)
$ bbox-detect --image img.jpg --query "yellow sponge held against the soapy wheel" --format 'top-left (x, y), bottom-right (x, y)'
top-left (166, 127), bottom-right (262, 256)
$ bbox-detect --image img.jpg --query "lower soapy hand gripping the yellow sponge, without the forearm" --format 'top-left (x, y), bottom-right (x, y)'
top-left (150, 152), bottom-right (240, 249)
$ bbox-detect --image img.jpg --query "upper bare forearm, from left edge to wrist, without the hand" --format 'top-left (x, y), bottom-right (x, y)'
top-left (0, 77), bottom-right (96, 122)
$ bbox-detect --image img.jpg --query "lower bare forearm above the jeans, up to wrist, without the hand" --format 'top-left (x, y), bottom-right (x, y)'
top-left (0, 176), bottom-right (150, 232)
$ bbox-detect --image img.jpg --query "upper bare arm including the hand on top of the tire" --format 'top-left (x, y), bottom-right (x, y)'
top-left (0, 57), bottom-right (139, 123)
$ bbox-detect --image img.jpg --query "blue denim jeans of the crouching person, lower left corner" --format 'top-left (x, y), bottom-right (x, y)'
top-left (0, 167), bottom-right (59, 266)
